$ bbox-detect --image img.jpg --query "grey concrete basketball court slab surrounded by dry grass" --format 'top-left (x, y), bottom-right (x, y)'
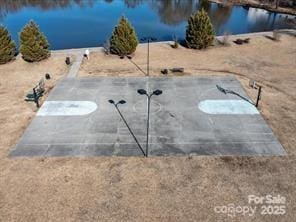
top-left (10, 76), bottom-right (285, 156)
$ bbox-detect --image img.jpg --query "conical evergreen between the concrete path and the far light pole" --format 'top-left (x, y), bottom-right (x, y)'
top-left (110, 16), bottom-right (138, 55)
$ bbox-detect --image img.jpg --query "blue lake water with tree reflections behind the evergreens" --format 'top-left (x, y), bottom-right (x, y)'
top-left (0, 0), bottom-right (295, 49)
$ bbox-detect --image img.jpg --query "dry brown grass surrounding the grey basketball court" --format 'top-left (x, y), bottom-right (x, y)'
top-left (0, 33), bottom-right (296, 222)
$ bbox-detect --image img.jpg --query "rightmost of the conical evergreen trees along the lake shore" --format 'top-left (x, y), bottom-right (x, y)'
top-left (186, 9), bottom-right (215, 49)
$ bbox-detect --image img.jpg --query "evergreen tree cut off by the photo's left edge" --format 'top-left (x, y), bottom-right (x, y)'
top-left (0, 26), bottom-right (16, 64)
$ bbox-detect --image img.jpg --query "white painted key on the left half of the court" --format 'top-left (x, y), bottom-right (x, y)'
top-left (37, 101), bottom-right (98, 116)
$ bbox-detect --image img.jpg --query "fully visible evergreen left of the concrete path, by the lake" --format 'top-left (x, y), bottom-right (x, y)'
top-left (20, 21), bottom-right (50, 62)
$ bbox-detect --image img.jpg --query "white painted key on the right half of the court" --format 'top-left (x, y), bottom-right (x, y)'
top-left (198, 100), bottom-right (259, 115)
